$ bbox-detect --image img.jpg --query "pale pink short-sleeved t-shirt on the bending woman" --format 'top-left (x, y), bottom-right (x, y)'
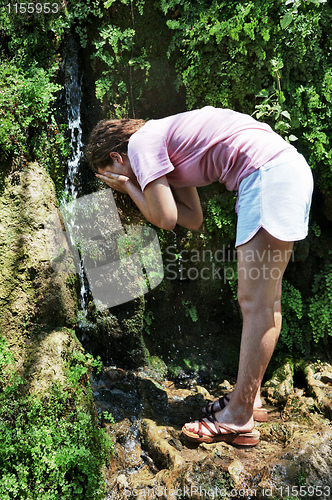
top-left (128, 106), bottom-right (295, 191)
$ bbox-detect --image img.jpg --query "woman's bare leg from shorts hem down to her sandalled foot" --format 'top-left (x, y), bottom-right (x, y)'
top-left (186, 229), bottom-right (293, 435)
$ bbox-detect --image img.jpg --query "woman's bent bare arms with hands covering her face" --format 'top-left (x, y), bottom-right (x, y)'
top-left (97, 173), bottom-right (203, 230)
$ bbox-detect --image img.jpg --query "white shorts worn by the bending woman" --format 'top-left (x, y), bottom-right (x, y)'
top-left (235, 150), bottom-right (313, 247)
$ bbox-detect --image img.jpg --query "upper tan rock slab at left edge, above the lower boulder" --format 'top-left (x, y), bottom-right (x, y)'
top-left (0, 163), bottom-right (76, 354)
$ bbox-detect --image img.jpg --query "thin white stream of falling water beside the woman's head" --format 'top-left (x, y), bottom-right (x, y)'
top-left (63, 38), bottom-right (87, 327)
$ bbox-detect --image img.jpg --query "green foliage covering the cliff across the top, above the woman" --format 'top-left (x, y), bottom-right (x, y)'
top-left (0, 0), bottom-right (332, 188)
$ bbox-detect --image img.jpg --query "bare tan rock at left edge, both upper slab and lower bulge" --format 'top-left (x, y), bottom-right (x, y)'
top-left (0, 163), bottom-right (77, 393)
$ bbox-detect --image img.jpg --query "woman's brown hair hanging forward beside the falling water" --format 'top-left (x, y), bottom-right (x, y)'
top-left (85, 118), bottom-right (145, 171)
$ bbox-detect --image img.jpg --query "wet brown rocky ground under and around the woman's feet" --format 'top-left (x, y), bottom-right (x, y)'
top-left (91, 365), bottom-right (332, 500)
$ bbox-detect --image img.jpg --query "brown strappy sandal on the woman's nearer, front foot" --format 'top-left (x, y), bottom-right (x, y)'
top-left (182, 415), bottom-right (260, 446)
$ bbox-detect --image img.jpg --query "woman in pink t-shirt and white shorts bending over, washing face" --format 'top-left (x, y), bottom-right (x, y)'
top-left (87, 106), bottom-right (313, 446)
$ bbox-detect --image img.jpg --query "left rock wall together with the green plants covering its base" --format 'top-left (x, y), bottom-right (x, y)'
top-left (0, 163), bottom-right (110, 500)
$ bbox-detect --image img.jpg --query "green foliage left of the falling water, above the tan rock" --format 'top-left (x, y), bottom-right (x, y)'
top-left (0, 0), bottom-right (69, 197)
